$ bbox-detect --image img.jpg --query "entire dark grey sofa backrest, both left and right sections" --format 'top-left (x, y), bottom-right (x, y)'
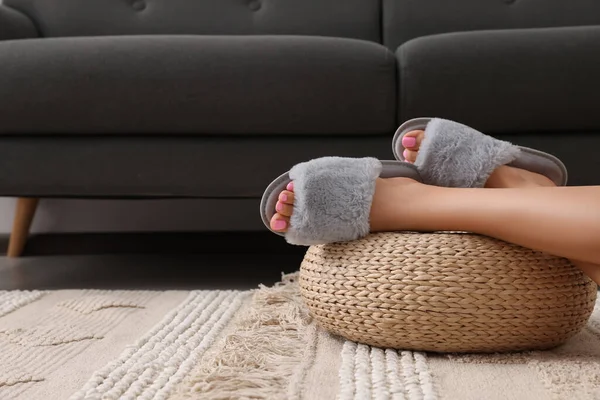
top-left (7, 0), bottom-right (600, 50)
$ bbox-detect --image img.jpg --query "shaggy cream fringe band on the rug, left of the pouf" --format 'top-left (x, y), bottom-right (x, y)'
top-left (180, 273), bottom-right (311, 399)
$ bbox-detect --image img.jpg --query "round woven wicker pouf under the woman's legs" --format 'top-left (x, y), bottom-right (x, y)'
top-left (299, 233), bottom-right (597, 352)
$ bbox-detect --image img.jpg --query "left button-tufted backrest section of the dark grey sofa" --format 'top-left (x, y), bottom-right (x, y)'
top-left (4, 0), bottom-right (381, 42)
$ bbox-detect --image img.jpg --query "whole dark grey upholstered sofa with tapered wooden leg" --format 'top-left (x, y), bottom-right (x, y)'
top-left (0, 0), bottom-right (600, 255)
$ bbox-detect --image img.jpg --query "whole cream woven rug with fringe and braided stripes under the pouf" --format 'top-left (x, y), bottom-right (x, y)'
top-left (0, 275), bottom-right (600, 400)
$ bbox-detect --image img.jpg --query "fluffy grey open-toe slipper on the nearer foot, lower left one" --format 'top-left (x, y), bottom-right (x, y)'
top-left (260, 157), bottom-right (422, 246)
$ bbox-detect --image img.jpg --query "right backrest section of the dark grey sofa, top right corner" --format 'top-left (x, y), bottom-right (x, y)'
top-left (381, 0), bottom-right (600, 50)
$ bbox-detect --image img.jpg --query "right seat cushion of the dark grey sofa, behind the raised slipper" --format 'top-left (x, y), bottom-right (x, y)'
top-left (397, 26), bottom-right (600, 133)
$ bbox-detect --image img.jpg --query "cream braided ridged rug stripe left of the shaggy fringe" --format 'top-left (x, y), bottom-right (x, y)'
top-left (71, 291), bottom-right (246, 399)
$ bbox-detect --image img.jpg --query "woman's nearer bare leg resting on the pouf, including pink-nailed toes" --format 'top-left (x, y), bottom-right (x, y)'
top-left (272, 178), bottom-right (600, 264)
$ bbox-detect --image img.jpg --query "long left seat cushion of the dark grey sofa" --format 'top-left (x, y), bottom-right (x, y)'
top-left (0, 36), bottom-right (397, 134)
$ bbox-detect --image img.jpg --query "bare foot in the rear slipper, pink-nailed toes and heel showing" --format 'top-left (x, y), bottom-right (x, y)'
top-left (402, 130), bottom-right (556, 188)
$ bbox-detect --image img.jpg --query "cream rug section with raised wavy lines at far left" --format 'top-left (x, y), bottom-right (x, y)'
top-left (0, 291), bottom-right (161, 399)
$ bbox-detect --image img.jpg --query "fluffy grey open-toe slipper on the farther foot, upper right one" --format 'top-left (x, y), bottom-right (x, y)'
top-left (392, 118), bottom-right (567, 187)
